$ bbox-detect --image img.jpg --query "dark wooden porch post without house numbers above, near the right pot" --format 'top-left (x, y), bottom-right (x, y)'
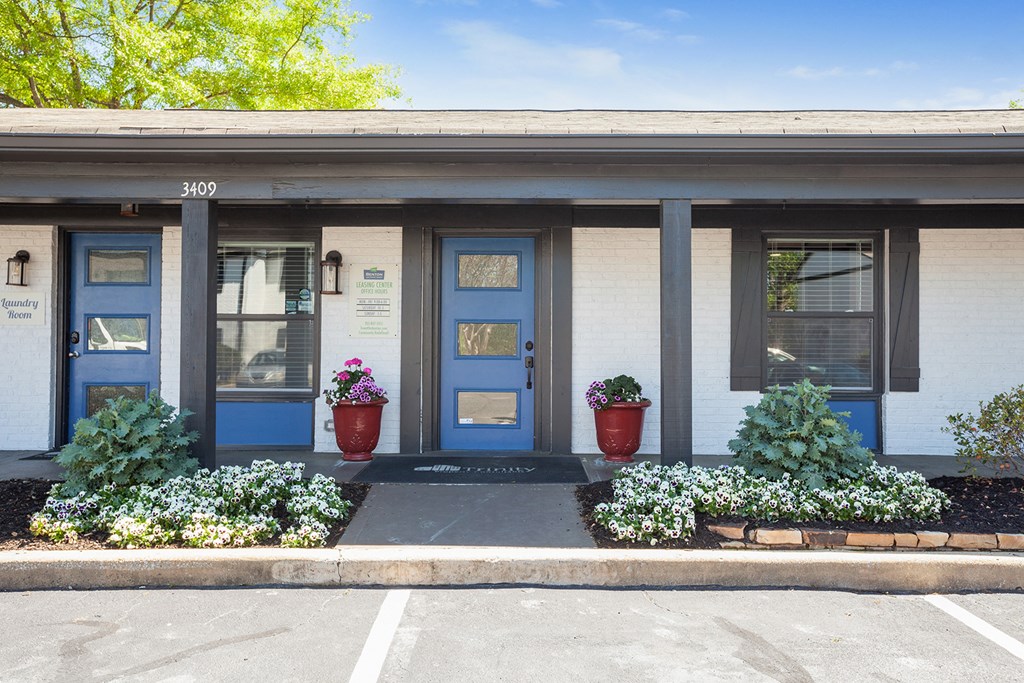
top-left (660, 200), bottom-right (693, 465)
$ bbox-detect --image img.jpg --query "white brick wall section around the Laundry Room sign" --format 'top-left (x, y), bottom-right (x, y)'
top-left (0, 225), bottom-right (56, 451)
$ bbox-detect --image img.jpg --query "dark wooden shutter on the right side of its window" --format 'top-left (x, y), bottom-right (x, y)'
top-left (889, 228), bottom-right (921, 391)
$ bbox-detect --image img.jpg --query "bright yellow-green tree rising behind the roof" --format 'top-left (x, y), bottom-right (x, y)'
top-left (0, 0), bottom-right (400, 110)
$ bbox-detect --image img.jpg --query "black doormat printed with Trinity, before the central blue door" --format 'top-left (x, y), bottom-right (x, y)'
top-left (352, 456), bottom-right (589, 483)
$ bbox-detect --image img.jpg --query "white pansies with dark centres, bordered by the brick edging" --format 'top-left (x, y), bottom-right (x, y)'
top-left (594, 463), bottom-right (949, 546)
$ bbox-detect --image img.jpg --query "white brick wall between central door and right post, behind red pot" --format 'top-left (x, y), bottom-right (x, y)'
top-left (572, 227), bottom-right (662, 453)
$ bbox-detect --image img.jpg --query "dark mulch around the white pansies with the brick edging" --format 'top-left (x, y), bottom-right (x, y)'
top-left (577, 477), bottom-right (1024, 549)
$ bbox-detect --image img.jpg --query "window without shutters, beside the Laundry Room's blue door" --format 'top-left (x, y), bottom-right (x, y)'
top-left (217, 242), bottom-right (315, 393)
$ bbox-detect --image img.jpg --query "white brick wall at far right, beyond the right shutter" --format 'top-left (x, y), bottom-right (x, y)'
top-left (884, 229), bottom-right (1024, 455)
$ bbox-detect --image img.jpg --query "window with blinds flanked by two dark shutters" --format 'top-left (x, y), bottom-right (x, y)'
top-left (766, 239), bottom-right (879, 391)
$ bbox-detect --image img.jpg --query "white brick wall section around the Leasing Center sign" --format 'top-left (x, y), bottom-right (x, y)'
top-left (313, 227), bottom-right (401, 453)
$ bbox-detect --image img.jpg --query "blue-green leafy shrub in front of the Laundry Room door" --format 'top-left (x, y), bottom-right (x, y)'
top-left (54, 391), bottom-right (199, 495)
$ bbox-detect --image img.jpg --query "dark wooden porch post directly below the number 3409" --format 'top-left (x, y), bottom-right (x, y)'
top-left (179, 200), bottom-right (217, 469)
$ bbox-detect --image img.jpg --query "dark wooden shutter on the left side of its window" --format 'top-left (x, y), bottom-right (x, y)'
top-left (729, 228), bottom-right (767, 391)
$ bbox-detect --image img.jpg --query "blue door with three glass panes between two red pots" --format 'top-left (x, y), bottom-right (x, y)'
top-left (438, 238), bottom-right (537, 451)
